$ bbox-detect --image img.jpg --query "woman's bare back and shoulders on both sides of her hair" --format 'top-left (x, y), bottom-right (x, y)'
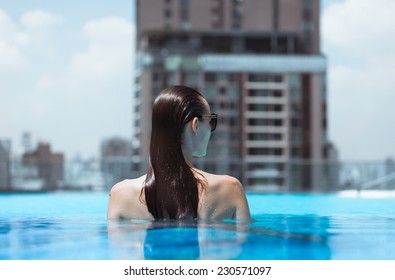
top-left (107, 169), bottom-right (250, 220)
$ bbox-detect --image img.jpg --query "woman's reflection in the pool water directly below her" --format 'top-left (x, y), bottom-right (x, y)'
top-left (108, 220), bottom-right (245, 260)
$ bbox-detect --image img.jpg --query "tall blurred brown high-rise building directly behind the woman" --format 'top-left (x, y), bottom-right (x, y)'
top-left (134, 0), bottom-right (328, 191)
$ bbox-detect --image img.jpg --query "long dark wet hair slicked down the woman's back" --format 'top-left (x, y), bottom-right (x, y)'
top-left (140, 86), bottom-right (210, 219)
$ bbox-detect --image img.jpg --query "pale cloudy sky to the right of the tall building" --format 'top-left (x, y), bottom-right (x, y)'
top-left (322, 0), bottom-right (395, 160)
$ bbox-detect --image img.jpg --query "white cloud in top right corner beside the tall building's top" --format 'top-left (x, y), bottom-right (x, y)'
top-left (322, 0), bottom-right (395, 59)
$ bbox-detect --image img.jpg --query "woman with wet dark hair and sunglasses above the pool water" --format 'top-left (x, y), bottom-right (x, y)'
top-left (108, 86), bottom-right (250, 220)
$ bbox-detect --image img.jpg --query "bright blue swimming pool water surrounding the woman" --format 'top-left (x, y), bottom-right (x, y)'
top-left (0, 193), bottom-right (395, 260)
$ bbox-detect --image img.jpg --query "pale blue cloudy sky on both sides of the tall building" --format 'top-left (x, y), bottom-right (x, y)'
top-left (0, 0), bottom-right (395, 161)
